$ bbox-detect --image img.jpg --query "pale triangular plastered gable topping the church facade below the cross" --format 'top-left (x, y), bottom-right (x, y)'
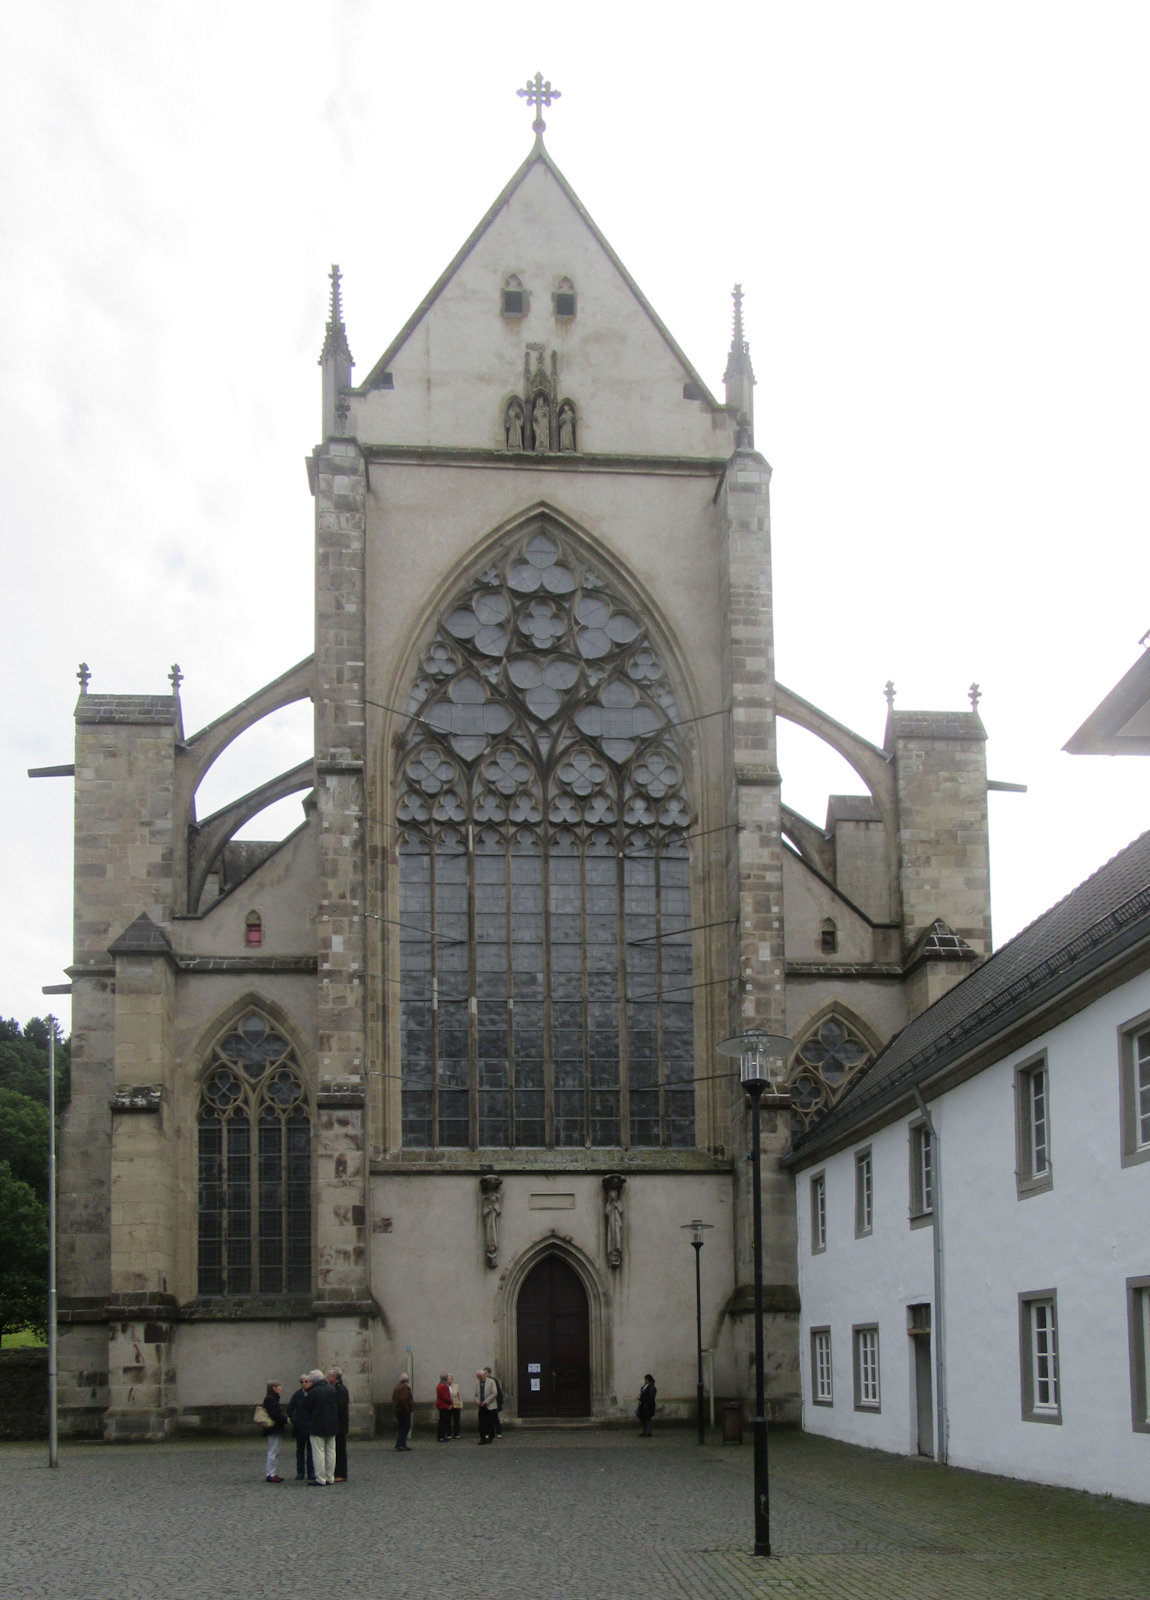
top-left (350, 144), bottom-right (734, 458)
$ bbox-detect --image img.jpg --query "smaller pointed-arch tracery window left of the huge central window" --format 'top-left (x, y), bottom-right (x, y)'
top-left (198, 1010), bottom-right (312, 1294)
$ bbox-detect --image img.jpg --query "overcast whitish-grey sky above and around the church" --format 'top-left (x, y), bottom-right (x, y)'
top-left (0, 0), bottom-right (1150, 1022)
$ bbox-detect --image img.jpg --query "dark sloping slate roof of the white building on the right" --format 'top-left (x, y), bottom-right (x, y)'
top-left (787, 832), bottom-right (1150, 1165)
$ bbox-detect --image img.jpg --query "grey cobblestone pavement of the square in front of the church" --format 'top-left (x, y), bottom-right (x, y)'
top-left (0, 1429), bottom-right (1150, 1600)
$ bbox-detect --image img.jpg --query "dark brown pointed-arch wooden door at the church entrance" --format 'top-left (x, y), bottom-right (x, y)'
top-left (515, 1256), bottom-right (590, 1416)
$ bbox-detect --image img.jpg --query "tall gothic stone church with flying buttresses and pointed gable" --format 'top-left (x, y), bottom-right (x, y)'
top-left (59, 109), bottom-right (990, 1438)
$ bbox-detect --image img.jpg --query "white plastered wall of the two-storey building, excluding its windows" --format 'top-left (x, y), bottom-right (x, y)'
top-left (795, 974), bottom-right (1150, 1499)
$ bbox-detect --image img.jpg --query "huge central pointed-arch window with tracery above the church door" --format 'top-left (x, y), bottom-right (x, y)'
top-left (397, 531), bottom-right (694, 1147)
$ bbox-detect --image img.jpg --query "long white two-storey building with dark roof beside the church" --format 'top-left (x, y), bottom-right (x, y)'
top-left (787, 834), bottom-right (1150, 1501)
